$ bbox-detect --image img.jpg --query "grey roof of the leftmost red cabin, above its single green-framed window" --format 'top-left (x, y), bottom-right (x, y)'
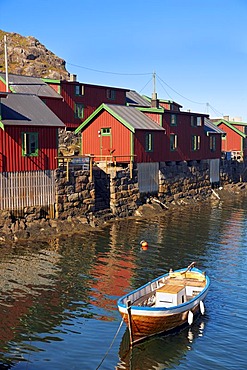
top-left (1, 93), bottom-right (65, 127)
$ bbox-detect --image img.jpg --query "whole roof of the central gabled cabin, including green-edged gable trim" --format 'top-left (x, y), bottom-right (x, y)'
top-left (75, 103), bottom-right (165, 133)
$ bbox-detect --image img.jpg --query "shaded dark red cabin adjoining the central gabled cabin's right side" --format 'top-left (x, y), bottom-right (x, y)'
top-left (127, 91), bottom-right (223, 161)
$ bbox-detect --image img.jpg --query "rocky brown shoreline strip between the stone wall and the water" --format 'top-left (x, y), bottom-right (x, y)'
top-left (0, 183), bottom-right (247, 247)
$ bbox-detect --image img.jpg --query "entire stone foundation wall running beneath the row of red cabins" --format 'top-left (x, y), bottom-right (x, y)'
top-left (0, 161), bottom-right (247, 241)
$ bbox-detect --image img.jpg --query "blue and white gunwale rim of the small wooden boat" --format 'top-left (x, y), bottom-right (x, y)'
top-left (117, 267), bottom-right (210, 313)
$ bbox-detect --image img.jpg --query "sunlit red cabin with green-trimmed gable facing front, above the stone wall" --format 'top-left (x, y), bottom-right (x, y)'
top-left (75, 104), bottom-right (165, 162)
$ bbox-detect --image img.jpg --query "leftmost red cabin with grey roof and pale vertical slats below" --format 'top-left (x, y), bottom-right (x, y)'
top-left (0, 93), bottom-right (64, 210)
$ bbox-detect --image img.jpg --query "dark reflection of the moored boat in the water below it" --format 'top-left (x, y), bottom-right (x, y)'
top-left (116, 320), bottom-right (205, 370)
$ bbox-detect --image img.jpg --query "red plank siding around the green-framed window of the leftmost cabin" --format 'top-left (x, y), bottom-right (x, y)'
top-left (0, 126), bottom-right (57, 172)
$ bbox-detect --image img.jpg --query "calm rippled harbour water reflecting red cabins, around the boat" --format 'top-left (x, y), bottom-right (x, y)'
top-left (0, 195), bottom-right (247, 370)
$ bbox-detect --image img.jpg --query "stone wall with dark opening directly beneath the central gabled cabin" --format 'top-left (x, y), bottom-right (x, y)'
top-left (55, 167), bottom-right (141, 223)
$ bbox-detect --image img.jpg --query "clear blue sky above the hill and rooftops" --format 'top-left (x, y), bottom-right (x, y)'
top-left (0, 0), bottom-right (247, 122)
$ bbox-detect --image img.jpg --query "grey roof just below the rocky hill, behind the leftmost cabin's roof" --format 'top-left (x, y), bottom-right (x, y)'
top-left (0, 72), bottom-right (62, 99)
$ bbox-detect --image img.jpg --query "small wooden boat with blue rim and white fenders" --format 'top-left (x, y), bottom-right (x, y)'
top-left (117, 262), bottom-right (210, 345)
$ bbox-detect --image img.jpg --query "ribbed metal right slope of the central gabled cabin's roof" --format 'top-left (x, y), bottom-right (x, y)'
top-left (104, 104), bottom-right (165, 131)
